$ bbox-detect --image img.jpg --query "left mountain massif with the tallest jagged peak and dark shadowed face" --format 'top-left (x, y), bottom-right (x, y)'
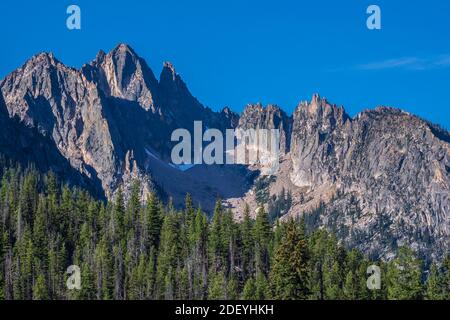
top-left (0, 44), bottom-right (241, 201)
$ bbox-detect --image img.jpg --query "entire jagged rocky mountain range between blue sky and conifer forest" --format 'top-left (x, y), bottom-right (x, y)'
top-left (0, 44), bottom-right (450, 260)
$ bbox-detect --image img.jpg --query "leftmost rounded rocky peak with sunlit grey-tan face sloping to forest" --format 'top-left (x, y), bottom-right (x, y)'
top-left (0, 53), bottom-right (126, 196)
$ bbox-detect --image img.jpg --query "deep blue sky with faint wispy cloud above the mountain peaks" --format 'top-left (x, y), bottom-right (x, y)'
top-left (0, 0), bottom-right (450, 128)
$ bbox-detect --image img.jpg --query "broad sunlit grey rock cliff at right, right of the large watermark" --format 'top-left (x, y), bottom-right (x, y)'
top-left (290, 96), bottom-right (450, 258)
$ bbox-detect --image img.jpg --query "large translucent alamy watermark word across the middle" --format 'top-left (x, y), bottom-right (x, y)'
top-left (171, 121), bottom-right (280, 175)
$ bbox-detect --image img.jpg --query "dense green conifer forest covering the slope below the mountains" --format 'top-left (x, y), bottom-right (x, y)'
top-left (0, 165), bottom-right (450, 299)
